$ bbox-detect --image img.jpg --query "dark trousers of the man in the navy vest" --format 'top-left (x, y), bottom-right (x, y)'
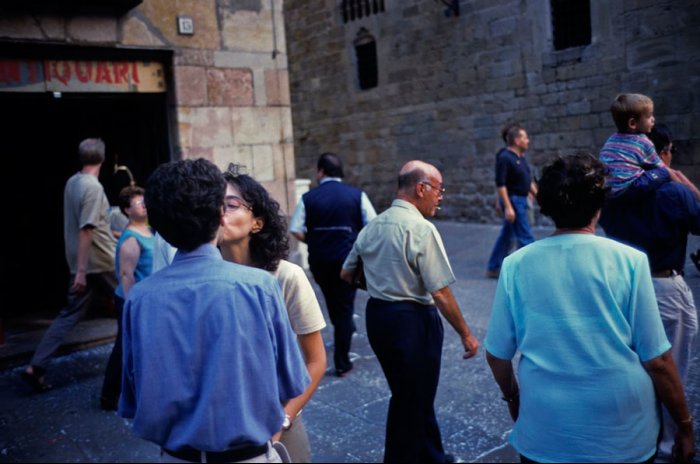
top-left (309, 261), bottom-right (356, 371)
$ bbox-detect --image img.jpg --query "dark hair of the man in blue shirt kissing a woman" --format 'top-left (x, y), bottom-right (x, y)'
top-left (145, 158), bottom-right (226, 251)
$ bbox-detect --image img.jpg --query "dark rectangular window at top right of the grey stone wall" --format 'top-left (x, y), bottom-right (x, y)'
top-left (551, 0), bottom-right (591, 50)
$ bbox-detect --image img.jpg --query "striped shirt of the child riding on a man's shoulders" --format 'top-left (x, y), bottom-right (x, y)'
top-left (599, 133), bottom-right (665, 196)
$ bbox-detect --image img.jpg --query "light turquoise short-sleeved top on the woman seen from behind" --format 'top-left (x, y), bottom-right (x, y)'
top-left (484, 234), bottom-right (671, 462)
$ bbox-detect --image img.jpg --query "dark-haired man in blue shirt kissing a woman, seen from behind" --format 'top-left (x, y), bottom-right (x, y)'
top-left (119, 159), bottom-right (310, 462)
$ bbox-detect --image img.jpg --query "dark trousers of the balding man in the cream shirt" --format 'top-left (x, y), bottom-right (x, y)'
top-left (366, 298), bottom-right (445, 462)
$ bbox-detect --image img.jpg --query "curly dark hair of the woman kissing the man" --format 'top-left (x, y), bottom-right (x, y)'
top-left (224, 165), bottom-right (289, 272)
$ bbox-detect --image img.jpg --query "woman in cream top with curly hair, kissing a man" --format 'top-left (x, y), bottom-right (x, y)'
top-left (219, 165), bottom-right (326, 462)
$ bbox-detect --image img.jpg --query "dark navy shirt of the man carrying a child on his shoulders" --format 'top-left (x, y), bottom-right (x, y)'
top-left (600, 182), bottom-right (700, 272)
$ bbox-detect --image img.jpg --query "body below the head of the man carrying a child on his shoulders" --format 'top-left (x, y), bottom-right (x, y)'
top-left (600, 176), bottom-right (700, 459)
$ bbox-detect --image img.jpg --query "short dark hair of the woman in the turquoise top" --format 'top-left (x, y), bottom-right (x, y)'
top-left (537, 152), bottom-right (609, 229)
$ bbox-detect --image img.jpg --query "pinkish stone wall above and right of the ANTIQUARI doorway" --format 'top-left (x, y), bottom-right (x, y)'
top-left (0, 0), bottom-right (295, 211)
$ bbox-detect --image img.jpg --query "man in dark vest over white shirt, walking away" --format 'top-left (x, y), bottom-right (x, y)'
top-left (289, 153), bottom-right (377, 377)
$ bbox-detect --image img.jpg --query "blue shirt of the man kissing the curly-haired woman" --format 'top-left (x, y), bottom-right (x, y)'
top-left (119, 244), bottom-right (310, 451)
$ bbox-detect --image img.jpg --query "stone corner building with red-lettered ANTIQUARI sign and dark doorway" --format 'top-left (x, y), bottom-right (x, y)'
top-left (0, 0), bottom-right (296, 312)
